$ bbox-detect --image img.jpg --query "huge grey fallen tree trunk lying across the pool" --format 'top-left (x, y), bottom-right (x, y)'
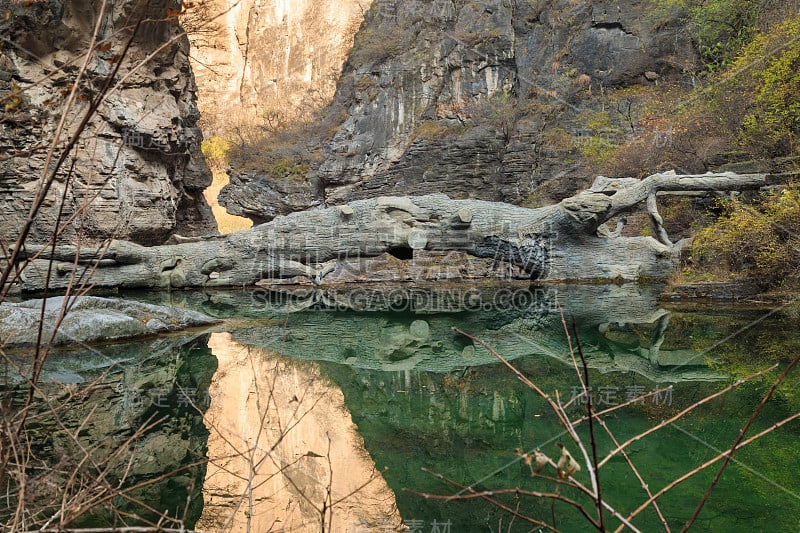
top-left (14, 172), bottom-right (770, 291)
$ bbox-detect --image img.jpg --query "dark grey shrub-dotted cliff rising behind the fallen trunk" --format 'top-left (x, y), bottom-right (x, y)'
top-left (220, 0), bottom-right (694, 221)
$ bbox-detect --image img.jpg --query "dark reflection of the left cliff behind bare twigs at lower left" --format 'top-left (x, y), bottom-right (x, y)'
top-left (0, 335), bottom-right (216, 528)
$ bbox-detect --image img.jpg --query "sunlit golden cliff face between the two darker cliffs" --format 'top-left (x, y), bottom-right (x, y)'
top-left (189, 0), bottom-right (372, 131)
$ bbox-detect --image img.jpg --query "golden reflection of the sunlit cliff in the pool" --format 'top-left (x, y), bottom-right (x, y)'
top-left (197, 333), bottom-right (400, 532)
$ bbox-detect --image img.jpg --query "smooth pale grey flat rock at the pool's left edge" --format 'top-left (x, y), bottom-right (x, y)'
top-left (0, 296), bottom-right (216, 349)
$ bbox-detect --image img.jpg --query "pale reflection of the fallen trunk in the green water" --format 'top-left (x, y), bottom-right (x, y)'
top-left (203, 285), bottom-right (722, 383)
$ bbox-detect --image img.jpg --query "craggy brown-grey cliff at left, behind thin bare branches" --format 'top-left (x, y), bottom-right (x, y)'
top-left (0, 0), bottom-right (215, 244)
